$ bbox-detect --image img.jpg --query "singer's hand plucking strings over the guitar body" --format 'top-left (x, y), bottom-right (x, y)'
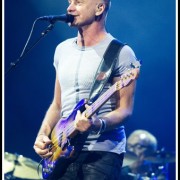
top-left (33, 134), bottom-right (52, 158)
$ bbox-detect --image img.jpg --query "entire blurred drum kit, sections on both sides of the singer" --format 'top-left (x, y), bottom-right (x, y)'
top-left (3, 150), bottom-right (175, 180)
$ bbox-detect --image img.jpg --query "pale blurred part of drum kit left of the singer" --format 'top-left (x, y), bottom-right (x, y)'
top-left (3, 152), bottom-right (42, 180)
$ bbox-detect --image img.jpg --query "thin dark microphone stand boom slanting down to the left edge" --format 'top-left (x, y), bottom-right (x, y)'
top-left (5, 19), bottom-right (55, 75)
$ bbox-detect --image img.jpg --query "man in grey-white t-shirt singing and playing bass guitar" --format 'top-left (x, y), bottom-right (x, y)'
top-left (34, 0), bottom-right (139, 180)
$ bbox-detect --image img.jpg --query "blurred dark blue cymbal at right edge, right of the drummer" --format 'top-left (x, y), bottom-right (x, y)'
top-left (145, 151), bottom-right (175, 164)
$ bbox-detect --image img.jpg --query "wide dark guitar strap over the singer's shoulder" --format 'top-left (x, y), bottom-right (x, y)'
top-left (89, 39), bottom-right (125, 104)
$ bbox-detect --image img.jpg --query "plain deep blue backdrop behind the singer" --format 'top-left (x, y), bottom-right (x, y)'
top-left (4, 0), bottom-right (176, 179)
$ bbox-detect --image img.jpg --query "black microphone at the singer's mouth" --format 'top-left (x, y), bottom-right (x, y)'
top-left (37, 14), bottom-right (74, 23)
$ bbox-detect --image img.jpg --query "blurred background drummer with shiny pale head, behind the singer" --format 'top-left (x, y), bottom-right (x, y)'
top-left (120, 129), bottom-right (160, 180)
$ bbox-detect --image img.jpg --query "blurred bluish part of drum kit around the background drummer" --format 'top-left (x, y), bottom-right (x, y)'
top-left (123, 149), bottom-right (175, 180)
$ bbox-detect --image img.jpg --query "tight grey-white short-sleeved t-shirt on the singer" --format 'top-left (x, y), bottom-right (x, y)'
top-left (54, 34), bottom-right (137, 154)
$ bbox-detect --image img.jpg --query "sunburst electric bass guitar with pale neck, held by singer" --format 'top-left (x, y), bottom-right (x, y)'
top-left (42, 68), bottom-right (139, 179)
